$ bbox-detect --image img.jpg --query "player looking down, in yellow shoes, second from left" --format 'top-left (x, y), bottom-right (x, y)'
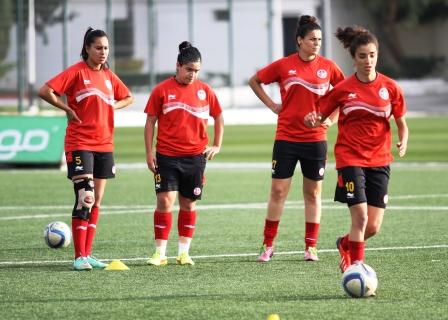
top-left (145, 41), bottom-right (224, 266)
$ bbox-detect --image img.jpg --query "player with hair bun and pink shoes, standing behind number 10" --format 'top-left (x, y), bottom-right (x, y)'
top-left (249, 16), bottom-right (344, 262)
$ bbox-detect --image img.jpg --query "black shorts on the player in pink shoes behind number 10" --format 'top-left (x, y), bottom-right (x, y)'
top-left (272, 140), bottom-right (327, 181)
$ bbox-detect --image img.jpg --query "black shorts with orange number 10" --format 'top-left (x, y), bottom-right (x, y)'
top-left (334, 166), bottom-right (390, 208)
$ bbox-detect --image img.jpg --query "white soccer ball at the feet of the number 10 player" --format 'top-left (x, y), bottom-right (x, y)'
top-left (342, 263), bottom-right (378, 298)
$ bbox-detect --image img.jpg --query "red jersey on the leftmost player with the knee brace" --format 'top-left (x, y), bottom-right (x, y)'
top-left (47, 61), bottom-right (130, 152)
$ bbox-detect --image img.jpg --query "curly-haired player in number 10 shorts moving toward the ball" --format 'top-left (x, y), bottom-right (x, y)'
top-left (305, 27), bottom-right (408, 272)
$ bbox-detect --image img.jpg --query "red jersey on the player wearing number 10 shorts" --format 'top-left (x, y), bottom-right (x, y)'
top-left (318, 73), bottom-right (406, 169)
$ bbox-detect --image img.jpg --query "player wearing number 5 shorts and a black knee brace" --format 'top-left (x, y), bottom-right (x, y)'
top-left (39, 27), bottom-right (133, 270)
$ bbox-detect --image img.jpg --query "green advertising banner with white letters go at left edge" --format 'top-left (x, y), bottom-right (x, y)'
top-left (0, 116), bottom-right (67, 164)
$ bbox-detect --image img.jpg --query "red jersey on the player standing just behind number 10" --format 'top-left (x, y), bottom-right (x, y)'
top-left (257, 53), bottom-right (344, 142)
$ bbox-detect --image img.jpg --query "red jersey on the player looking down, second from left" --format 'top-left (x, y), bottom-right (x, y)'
top-left (145, 77), bottom-right (222, 157)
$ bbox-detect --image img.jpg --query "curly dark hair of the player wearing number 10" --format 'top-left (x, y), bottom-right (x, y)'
top-left (335, 26), bottom-right (379, 57)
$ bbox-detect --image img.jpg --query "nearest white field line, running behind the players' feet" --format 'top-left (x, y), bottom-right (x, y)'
top-left (0, 244), bottom-right (448, 266)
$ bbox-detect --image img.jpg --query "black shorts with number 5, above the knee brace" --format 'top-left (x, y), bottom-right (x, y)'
top-left (65, 150), bottom-right (115, 179)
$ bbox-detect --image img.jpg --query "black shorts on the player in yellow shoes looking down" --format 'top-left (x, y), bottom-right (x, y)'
top-left (154, 152), bottom-right (206, 200)
